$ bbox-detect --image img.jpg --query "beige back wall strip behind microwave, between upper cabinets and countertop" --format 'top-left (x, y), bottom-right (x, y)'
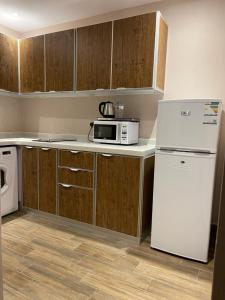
top-left (20, 95), bottom-right (159, 138)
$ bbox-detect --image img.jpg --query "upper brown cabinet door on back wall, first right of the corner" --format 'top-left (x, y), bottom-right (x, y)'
top-left (20, 35), bottom-right (44, 92)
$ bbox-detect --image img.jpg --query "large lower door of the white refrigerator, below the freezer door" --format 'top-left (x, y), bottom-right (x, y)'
top-left (151, 151), bottom-right (216, 262)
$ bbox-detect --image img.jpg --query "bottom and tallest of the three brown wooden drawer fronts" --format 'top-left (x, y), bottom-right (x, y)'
top-left (59, 185), bottom-right (93, 224)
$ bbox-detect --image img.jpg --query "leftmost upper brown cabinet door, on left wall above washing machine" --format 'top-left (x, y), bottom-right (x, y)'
top-left (0, 33), bottom-right (18, 92)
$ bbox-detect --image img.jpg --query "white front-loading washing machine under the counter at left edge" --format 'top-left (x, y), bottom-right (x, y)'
top-left (0, 147), bottom-right (19, 216)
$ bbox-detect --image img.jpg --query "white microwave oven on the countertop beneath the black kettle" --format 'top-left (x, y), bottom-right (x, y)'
top-left (93, 120), bottom-right (139, 145)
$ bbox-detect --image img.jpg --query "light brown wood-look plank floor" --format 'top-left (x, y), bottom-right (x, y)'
top-left (2, 212), bottom-right (213, 300)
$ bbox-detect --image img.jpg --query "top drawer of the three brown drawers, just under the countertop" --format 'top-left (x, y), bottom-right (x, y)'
top-left (59, 150), bottom-right (94, 170)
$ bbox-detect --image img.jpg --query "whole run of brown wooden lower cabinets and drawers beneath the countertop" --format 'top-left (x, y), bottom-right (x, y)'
top-left (22, 147), bottom-right (154, 238)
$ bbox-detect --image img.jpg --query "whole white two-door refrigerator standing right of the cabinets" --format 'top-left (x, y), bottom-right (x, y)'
top-left (151, 99), bottom-right (222, 262)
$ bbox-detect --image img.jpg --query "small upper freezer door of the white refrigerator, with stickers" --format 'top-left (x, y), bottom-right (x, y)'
top-left (156, 100), bottom-right (221, 153)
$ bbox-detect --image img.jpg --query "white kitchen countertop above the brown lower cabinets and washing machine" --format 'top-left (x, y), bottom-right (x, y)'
top-left (0, 137), bottom-right (155, 157)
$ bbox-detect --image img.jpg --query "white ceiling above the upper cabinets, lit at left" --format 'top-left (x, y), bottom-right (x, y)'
top-left (0, 0), bottom-right (157, 33)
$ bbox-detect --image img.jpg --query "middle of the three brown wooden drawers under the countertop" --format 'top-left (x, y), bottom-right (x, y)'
top-left (58, 168), bottom-right (93, 188)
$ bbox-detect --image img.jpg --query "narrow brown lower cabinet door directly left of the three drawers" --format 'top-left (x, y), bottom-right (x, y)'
top-left (39, 148), bottom-right (57, 214)
